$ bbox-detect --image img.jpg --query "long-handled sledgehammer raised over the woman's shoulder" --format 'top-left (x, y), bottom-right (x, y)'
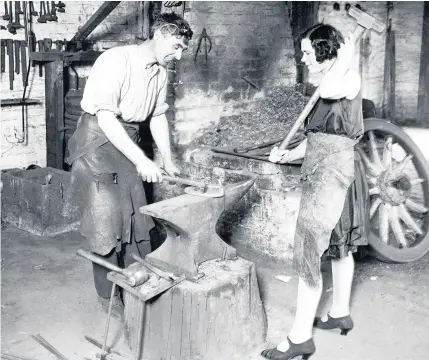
top-left (270, 6), bottom-right (385, 160)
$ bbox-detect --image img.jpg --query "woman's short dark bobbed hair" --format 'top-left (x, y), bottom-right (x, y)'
top-left (299, 24), bottom-right (344, 64)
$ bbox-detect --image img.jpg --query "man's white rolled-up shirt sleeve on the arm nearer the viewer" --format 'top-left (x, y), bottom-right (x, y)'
top-left (81, 49), bottom-right (127, 116)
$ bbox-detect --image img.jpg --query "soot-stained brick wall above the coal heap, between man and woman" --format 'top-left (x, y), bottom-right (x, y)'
top-left (172, 1), bottom-right (295, 145)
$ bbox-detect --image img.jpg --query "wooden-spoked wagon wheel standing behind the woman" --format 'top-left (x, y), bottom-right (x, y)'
top-left (358, 118), bottom-right (429, 263)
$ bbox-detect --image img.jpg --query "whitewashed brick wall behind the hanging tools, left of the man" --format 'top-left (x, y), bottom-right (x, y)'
top-left (0, 1), bottom-right (139, 169)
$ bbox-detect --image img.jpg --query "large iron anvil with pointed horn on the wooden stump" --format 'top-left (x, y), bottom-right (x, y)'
top-left (140, 179), bottom-right (255, 277)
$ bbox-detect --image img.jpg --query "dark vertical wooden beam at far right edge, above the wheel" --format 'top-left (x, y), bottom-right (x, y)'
top-left (417, 1), bottom-right (429, 124)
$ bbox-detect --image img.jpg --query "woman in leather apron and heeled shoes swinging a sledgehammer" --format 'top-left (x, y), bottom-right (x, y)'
top-left (262, 24), bottom-right (368, 360)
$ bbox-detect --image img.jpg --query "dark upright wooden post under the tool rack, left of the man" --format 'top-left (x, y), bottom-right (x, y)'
top-left (45, 60), bottom-right (64, 169)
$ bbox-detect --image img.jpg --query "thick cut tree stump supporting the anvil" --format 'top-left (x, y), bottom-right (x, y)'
top-left (124, 258), bottom-right (266, 360)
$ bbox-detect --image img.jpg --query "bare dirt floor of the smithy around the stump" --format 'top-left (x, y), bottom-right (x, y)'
top-left (1, 226), bottom-right (429, 360)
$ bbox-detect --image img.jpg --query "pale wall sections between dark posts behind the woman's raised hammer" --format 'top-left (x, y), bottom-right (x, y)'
top-left (319, 1), bottom-right (429, 127)
